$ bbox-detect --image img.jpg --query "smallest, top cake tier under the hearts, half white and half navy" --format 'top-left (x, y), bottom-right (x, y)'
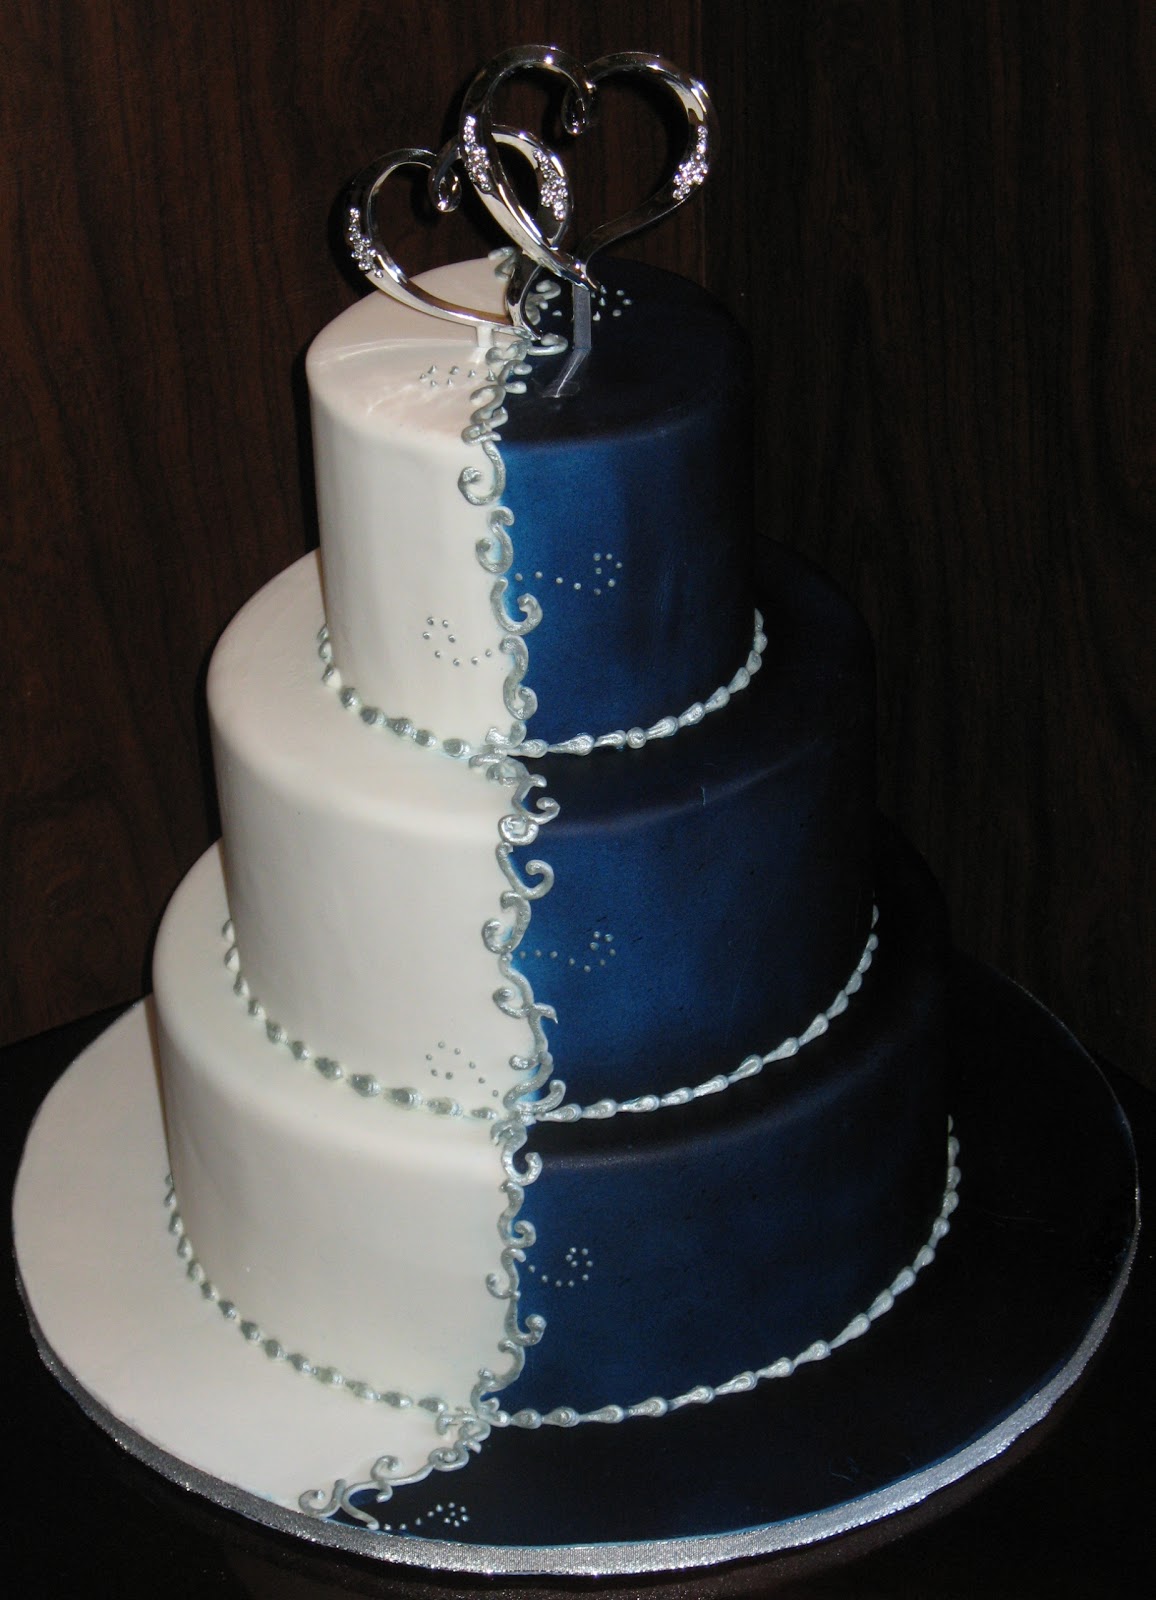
top-left (307, 261), bottom-right (753, 744)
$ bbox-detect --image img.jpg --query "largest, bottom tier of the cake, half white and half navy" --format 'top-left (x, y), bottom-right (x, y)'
top-left (155, 840), bottom-right (951, 1451)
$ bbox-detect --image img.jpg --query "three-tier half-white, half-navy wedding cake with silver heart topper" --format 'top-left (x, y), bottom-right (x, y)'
top-left (154, 53), bottom-right (957, 1522)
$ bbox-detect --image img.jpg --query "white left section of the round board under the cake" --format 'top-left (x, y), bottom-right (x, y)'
top-left (13, 1004), bottom-right (489, 1506)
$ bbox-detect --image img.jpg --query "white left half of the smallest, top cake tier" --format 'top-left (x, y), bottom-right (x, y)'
top-left (307, 261), bottom-right (509, 744)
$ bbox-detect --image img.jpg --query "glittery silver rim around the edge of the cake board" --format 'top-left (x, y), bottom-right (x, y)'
top-left (18, 979), bottom-right (1138, 1578)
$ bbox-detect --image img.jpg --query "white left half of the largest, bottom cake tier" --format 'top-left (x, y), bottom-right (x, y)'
top-left (154, 850), bottom-right (509, 1453)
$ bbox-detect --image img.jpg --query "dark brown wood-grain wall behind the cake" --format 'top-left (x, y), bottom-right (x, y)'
top-left (0, 0), bottom-right (1156, 1080)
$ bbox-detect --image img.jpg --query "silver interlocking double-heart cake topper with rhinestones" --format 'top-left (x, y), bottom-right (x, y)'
top-left (347, 45), bottom-right (719, 342)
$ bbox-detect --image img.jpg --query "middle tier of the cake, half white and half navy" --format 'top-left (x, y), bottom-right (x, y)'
top-left (208, 552), bottom-right (874, 1106)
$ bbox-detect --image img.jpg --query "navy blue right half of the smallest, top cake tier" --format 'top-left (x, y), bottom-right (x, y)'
top-left (501, 262), bottom-right (753, 742)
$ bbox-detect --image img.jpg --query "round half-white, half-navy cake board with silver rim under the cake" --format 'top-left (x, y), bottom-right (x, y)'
top-left (14, 962), bottom-right (1138, 1576)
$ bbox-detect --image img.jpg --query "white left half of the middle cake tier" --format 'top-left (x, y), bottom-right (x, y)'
top-left (205, 553), bottom-right (527, 1107)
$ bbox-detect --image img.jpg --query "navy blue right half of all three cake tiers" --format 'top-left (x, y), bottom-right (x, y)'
top-left (483, 266), bottom-right (946, 1433)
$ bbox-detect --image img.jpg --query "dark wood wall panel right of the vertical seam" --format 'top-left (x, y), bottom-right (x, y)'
top-left (706, 3), bottom-right (1156, 1080)
